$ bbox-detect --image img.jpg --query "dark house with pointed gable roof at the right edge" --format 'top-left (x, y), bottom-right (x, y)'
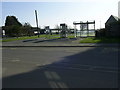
top-left (105, 15), bottom-right (120, 37)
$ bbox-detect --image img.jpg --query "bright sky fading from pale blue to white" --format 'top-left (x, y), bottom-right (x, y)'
top-left (2, 0), bottom-right (119, 28)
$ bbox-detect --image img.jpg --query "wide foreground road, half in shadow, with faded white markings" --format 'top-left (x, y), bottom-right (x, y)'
top-left (2, 47), bottom-right (119, 88)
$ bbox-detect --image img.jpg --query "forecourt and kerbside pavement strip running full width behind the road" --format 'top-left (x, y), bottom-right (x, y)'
top-left (2, 38), bottom-right (119, 47)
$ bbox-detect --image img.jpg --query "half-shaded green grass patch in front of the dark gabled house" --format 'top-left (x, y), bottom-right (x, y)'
top-left (80, 37), bottom-right (120, 43)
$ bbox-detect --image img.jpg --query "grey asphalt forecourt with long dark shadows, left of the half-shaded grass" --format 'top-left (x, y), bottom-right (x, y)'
top-left (2, 38), bottom-right (78, 46)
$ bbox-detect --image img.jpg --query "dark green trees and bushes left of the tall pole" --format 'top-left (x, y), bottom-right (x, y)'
top-left (4, 16), bottom-right (34, 37)
